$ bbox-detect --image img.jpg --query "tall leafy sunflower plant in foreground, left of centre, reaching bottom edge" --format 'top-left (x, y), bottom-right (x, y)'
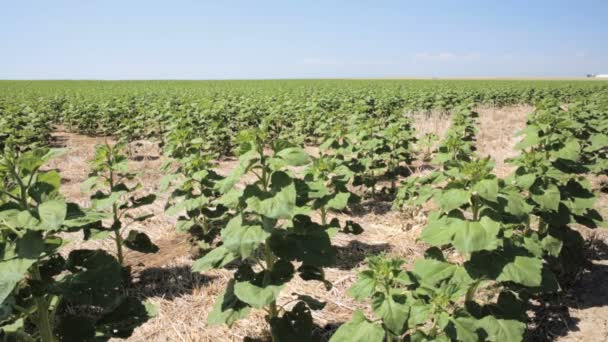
top-left (193, 130), bottom-right (356, 341)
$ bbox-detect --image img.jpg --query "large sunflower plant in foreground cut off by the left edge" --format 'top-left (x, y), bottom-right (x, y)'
top-left (0, 149), bottom-right (149, 342)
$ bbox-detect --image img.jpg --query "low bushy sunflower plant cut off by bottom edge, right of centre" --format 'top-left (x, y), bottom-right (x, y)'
top-left (331, 255), bottom-right (525, 342)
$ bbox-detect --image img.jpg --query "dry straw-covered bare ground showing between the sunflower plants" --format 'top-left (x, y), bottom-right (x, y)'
top-left (50, 106), bottom-right (608, 341)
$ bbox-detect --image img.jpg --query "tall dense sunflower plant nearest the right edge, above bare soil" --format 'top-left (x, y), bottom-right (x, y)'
top-left (510, 101), bottom-right (604, 280)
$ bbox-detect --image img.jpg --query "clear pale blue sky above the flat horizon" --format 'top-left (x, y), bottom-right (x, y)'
top-left (0, 0), bottom-right (608, 79)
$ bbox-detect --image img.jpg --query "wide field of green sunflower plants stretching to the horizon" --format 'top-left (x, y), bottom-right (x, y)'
top-left (0, 80), bottom-right (608, 342)
